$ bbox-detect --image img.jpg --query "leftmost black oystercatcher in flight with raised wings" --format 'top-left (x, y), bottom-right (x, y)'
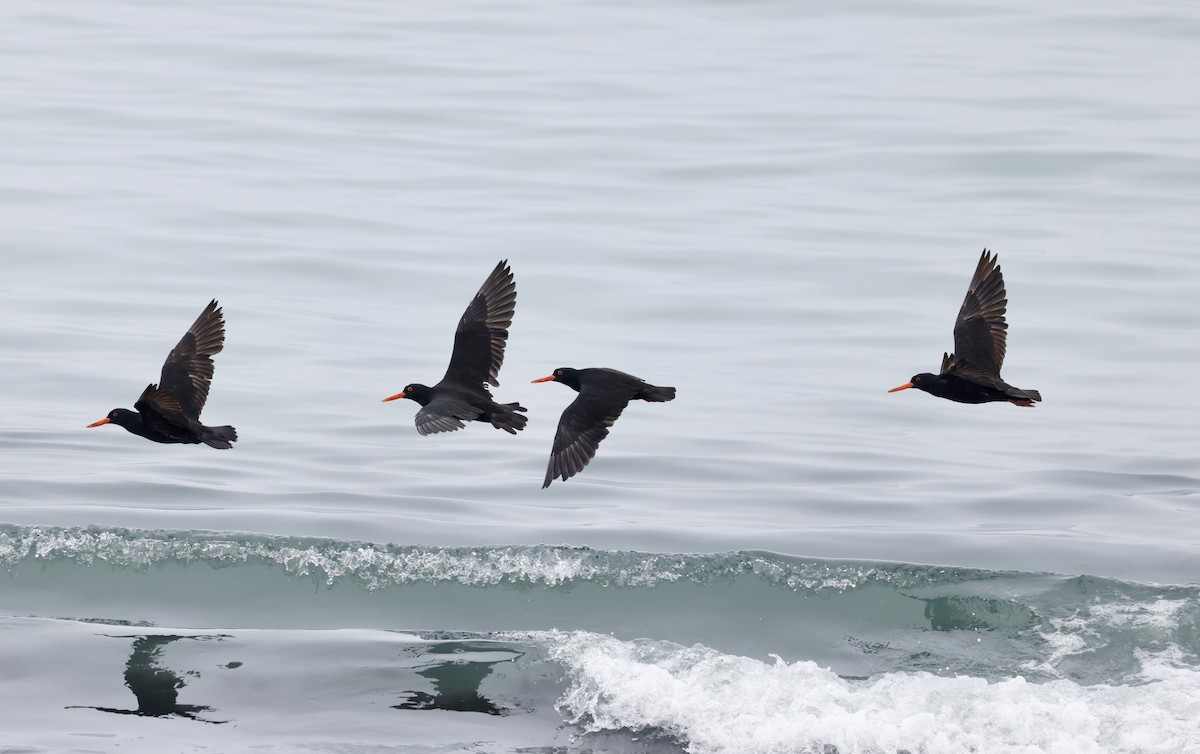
top-left (88, 300), bottom-right (238, 449)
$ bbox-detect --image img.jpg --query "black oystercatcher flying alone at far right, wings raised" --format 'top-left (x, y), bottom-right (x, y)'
top-left (888, 249), bottom-right (1042, 407)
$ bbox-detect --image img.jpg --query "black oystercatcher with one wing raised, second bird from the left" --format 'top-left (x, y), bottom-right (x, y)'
top-left (383, 261), bottom-right (527, 435)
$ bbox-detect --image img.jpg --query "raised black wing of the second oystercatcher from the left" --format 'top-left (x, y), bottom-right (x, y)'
top-left (443, 261), bottom-right (517, 388)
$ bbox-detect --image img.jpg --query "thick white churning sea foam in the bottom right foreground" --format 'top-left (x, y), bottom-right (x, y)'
top-left (541, 632), bottom-right (1200, 754)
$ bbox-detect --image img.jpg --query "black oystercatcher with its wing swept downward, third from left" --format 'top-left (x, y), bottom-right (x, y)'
top-left (534, 366), bottom-right (674, 490)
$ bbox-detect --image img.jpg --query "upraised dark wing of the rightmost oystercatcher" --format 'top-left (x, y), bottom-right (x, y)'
top-left (943, 249), bottom-right (1008, 376)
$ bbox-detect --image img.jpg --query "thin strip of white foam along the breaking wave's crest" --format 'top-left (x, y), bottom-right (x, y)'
top-left (0, 526), bottom-right (986, 591)
